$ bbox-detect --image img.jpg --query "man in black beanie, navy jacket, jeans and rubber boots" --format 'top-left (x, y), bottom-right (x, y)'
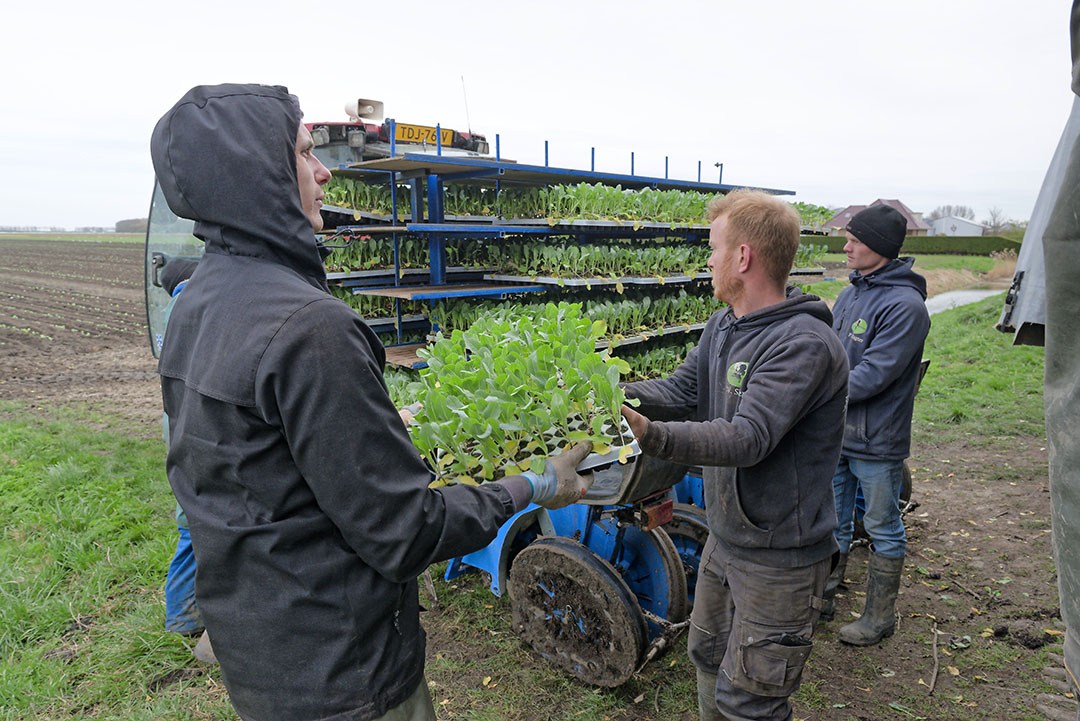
top-left (823, 204), bottom-right (930, 645)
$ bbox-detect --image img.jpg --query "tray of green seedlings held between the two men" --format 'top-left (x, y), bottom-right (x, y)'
top-left (396, 302), bottom-right (638, 496)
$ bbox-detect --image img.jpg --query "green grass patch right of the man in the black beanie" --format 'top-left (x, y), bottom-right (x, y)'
top-left (913, 294), bottom-right (1044, 444)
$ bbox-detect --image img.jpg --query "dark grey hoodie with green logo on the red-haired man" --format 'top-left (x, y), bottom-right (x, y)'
top-left (626, 288), bottom-right (848, 568)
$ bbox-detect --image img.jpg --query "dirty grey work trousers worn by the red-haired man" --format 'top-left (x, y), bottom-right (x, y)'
top-left (687, 533), bottom-right (832, 721)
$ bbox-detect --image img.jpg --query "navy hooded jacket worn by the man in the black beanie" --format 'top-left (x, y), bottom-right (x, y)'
top-left (833, 258), bottom-right (930, 460)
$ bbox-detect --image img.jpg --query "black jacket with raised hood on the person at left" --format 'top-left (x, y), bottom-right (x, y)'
top-left (151, 85), bottom-right (514, 721)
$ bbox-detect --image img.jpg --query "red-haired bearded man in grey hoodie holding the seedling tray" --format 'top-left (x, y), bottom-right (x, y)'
top-left (623, 190), bottom-right (848, 721)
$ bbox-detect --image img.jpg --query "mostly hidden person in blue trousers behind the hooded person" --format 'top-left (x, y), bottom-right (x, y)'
top-left (158, 258), bottom-right (216, 663)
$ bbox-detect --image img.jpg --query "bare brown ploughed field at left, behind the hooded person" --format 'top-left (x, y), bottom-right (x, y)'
top-left (0, 236), bottom-right (161, 430)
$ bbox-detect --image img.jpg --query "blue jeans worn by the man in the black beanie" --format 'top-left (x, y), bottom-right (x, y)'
top-left (833, 455), bottom-right (907, 558)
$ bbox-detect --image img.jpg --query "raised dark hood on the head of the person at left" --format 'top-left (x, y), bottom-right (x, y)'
top-left (150, 84), bottom-right (326, 286)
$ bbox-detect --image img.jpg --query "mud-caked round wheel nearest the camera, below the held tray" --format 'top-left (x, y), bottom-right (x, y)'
top-left (509, 536), bottom-right (647, 688)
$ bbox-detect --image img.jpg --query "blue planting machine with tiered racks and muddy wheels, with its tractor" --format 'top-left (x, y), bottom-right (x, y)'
top-left (146, 99), bottom-right (803, 686)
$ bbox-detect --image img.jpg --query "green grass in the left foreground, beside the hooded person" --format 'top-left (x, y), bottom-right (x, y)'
top-left (0, 404), bottom-right (236, 719)
